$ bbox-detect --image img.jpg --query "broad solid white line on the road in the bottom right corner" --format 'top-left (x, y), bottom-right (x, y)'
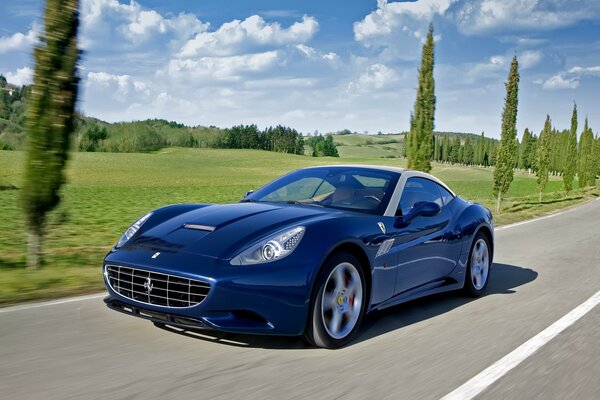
top-left (442, 290), bottom-right (600, 400)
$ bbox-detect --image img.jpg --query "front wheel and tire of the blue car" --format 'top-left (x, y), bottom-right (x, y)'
top-left (303, 252), bottom-right (367, 349)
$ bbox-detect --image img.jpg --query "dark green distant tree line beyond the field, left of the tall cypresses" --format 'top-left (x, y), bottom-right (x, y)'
top-left (0, 79), bottom-right (339, 157)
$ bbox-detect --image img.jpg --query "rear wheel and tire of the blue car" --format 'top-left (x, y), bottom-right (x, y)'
top-left (464, 232), bottom-right (492, 297)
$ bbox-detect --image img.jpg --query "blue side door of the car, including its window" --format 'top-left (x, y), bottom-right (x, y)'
top-left (394, 177), bottom-right (458, 295)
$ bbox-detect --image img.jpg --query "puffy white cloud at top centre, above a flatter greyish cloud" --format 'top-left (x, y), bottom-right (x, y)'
top-left (179, 15), bottom-right (319, 57)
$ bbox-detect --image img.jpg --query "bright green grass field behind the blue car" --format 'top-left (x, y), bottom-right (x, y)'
top-left (0, 147), bottom-right (598, 304)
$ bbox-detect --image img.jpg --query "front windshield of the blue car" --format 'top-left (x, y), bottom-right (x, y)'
top-left (242, 167), bottom-right (400, 214)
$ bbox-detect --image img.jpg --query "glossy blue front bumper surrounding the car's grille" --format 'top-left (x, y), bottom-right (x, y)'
top-left (103, 248), bottom-right (318, 336)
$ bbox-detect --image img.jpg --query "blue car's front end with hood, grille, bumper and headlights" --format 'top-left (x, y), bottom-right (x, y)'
top-left (103, 203), bottom-right (335, 335)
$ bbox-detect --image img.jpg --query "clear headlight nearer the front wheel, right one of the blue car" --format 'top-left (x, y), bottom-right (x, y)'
top-left (231, 226), bottom-right (304, 265)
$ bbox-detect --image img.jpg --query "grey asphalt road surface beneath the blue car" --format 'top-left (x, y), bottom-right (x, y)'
top-left (0, 201), bottom-right (600, 400)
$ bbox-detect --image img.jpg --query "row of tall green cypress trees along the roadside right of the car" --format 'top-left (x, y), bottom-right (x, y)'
top-left (405, 24), bottom-right (600, 212)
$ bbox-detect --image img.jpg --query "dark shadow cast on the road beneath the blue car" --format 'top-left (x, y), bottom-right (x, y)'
top-left (152, 263), bottom-right (538, 350)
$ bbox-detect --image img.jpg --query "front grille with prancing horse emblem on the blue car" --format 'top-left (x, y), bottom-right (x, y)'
top-left (106, 265), bottom-right (210, 308)
